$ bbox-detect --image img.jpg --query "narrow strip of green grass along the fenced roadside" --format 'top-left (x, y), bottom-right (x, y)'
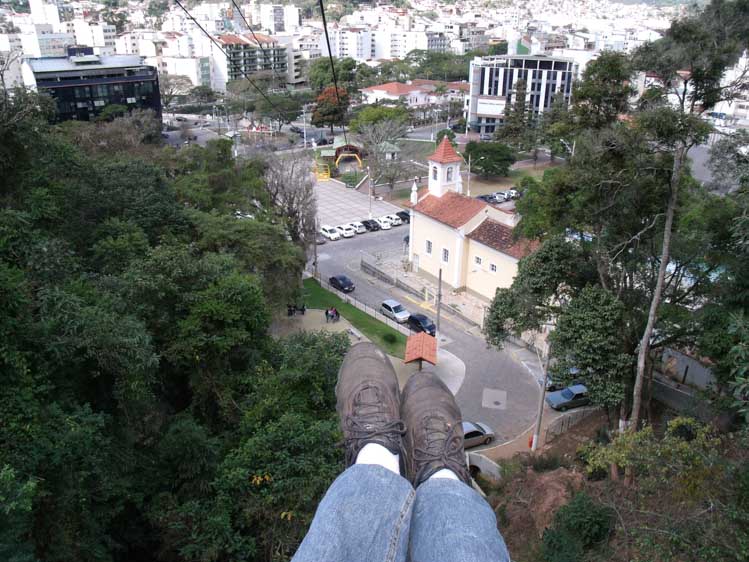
top-left (304, 278), bottom-right (406, 358)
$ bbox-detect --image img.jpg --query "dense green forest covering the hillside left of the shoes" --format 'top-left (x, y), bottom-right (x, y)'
top-left (0, 91), bottom-right (348, 562)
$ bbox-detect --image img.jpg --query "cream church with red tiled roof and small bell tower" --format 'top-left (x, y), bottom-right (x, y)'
top-left (408, 137), bottom-right (538, 300)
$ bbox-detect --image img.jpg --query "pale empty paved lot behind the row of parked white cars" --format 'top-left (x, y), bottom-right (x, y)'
top-left (316, 177), bottom-right (403, 226)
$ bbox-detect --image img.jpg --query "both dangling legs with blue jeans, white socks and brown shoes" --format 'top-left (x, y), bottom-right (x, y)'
top-left (292, 343), bottom-right (510, 562)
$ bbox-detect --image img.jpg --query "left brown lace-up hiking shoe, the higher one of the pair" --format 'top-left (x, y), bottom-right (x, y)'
top-left (335, 342), bottom-right (405, 468)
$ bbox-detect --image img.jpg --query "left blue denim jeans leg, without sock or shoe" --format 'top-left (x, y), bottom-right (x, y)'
top-left (292, 464), bottom-right (416, 562)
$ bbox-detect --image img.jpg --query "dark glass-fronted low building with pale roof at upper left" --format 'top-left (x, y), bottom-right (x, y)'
top-left (24, 47), bottom-right (161, 121)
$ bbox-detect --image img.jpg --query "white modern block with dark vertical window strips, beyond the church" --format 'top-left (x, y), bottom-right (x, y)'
top-left (468, 55), bottom-right (577, 133)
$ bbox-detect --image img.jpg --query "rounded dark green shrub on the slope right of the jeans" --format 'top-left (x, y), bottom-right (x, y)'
top-left (554, 492), bottom-right (613, 548)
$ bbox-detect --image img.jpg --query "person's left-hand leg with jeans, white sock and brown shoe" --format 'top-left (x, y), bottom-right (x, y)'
top-left (293, 343), bottom-right (415, 562)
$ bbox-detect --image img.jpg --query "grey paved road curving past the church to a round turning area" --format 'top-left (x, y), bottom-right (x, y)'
top-left (317, 221), bottom-right (539, 443)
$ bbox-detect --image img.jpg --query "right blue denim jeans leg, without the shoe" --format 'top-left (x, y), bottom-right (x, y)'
top-left (409, 478), bottom-right (510, 562)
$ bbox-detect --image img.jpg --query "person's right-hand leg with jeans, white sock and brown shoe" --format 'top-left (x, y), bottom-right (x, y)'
top-left (401, 373), bottom-right (510, 562)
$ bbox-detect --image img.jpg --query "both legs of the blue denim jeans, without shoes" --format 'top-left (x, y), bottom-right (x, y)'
top-left (292, 464), bottom-right (510, 562)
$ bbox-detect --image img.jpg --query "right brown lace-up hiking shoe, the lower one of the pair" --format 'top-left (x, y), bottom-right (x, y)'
top-left (401, 372), bottom-right (471, 488)
